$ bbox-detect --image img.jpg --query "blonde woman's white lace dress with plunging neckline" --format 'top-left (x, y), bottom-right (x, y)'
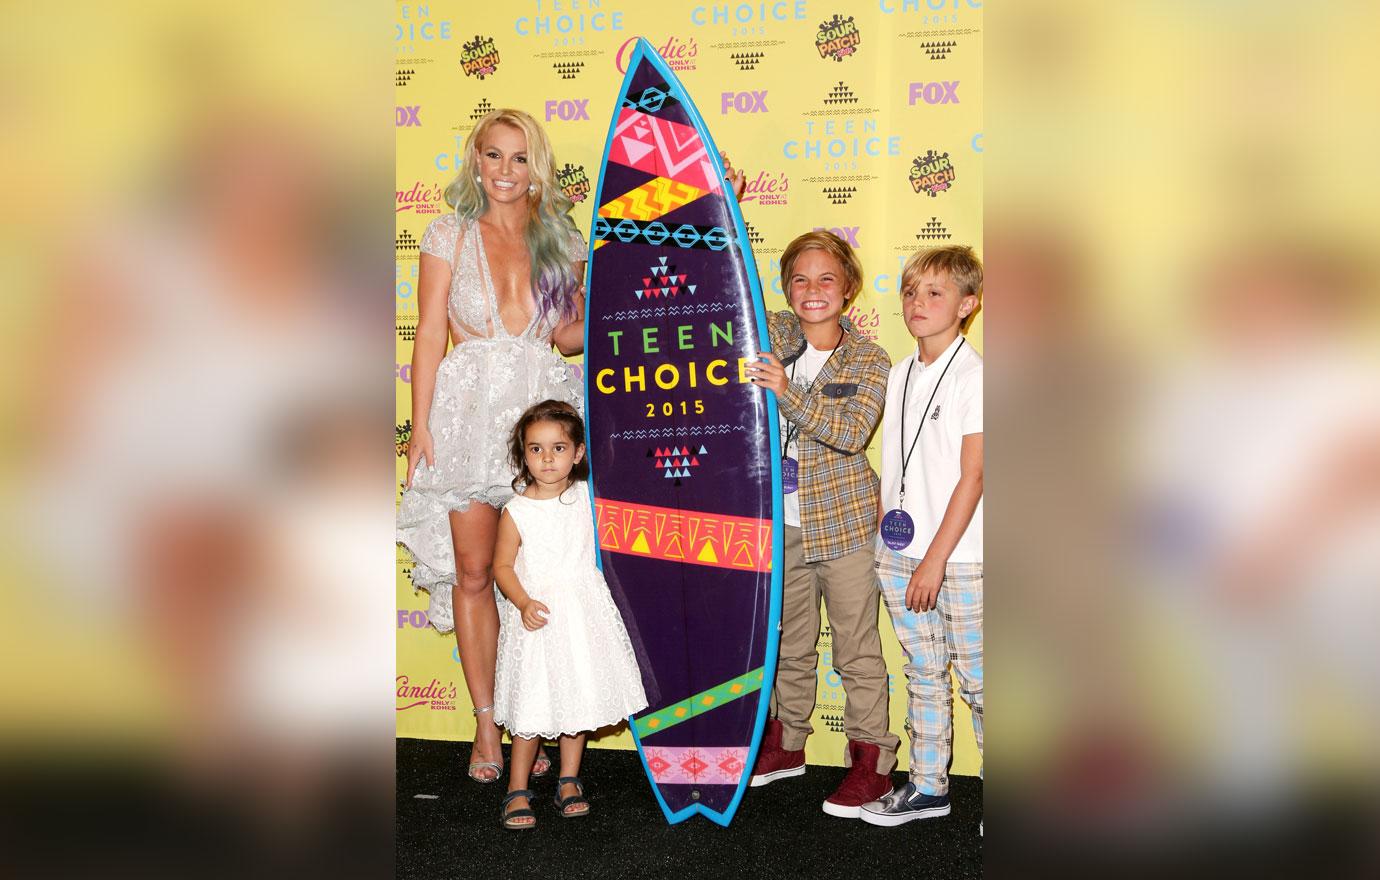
top-left (397, 214), bottom-right (585, 633)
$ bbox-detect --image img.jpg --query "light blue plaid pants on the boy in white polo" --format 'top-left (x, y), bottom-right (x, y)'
top-left (876, 538), bottom-right (983, 794)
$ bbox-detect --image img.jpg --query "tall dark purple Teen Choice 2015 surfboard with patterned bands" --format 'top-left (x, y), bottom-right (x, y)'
top-left (585, 39), bottom-right (781, 826)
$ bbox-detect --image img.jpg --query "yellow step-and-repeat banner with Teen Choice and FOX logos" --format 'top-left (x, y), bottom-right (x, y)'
top-left (392, 0), bottom-right (983, 774)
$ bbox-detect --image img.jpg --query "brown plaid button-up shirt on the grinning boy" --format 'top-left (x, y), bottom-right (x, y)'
top-left (767, 312), bottom-right (891, 563)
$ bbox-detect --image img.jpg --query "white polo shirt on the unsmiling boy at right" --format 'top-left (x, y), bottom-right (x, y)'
top-left (882, 335), bottom-right (983, 563)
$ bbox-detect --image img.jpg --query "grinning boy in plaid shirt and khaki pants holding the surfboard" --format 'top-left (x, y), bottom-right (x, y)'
top-left (747, 232), bottom-right (900, 818)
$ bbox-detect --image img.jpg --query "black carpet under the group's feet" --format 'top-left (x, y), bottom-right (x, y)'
top-left (396, 739), bottom-right (983, 880)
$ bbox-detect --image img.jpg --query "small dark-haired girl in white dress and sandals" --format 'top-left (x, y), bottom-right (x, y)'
top-left (494, 400), bottom-right (647, 830)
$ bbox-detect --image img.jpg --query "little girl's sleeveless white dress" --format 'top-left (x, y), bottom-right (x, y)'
top-left (494, 483), bottom-right (647, 739)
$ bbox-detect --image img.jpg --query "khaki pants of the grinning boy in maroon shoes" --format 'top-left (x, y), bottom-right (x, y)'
top-left (771, 526), bottom-right (901, 774)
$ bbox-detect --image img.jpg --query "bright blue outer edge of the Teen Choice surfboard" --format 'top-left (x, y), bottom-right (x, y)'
top-left (584, 37), bottom-right (785, 828)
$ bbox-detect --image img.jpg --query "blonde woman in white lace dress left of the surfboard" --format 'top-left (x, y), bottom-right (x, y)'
top-left (397, 109), bottom-right (585, 782)
